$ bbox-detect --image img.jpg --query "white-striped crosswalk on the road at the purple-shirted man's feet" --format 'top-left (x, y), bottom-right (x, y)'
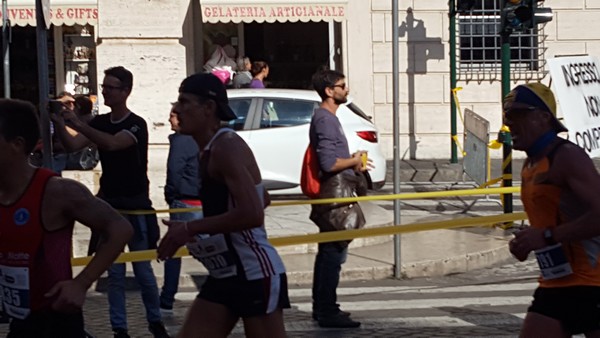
top-left (171, 279), bottom-right (537, 337)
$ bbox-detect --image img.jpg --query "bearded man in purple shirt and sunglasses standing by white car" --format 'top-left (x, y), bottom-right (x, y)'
top-left (310, 70), bottom-right (365, 328)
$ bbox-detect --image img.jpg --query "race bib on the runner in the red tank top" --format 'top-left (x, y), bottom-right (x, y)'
top-left (0, 265), bottom-right (31, 319)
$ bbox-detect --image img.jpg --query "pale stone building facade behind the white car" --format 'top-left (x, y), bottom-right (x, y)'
top-left (2, 0), bottom-right (600, 203)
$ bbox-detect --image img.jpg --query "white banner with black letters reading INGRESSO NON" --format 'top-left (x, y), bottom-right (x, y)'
top-left (548, 56), bottom-right (600, 157)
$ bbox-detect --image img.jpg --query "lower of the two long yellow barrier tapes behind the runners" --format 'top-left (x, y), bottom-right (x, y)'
top-left (71, 212), bottom-right (527, 266)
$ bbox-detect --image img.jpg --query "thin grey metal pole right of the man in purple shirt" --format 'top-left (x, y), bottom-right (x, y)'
top-left (392, 0), bottom-right (402, 278)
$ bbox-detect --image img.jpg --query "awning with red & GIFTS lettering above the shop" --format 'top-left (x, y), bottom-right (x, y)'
top-left (0, 0), bottom-right (98, 26)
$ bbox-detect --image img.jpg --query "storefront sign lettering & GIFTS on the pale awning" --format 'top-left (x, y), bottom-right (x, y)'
top-left (0, 6), bottom-right (98, 26)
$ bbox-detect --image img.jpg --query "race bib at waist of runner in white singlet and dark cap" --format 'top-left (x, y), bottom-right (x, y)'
top-left (186, 234), bottom-right (237, 278)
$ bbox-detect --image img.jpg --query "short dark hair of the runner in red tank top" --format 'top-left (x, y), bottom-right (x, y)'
top-left (0, 99), bottom-right (40, 154)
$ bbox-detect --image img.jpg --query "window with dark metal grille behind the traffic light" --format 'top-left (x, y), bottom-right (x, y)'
top-left (457, 0), bottom-right (546, 80)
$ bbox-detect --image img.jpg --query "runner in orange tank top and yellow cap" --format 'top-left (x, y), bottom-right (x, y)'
top-left (503, 83), bottom-right (600, 337)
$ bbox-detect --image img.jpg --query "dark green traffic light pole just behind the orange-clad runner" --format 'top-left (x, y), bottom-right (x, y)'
top-left (499, 32), bottom-right (513, 214)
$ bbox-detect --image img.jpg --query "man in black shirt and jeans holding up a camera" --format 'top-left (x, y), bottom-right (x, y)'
top-left (53, 67), bottom-right (168, 337)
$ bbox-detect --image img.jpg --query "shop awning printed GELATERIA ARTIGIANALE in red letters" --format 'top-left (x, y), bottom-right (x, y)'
top-left (200, 0), bottom-right (348, 23)
